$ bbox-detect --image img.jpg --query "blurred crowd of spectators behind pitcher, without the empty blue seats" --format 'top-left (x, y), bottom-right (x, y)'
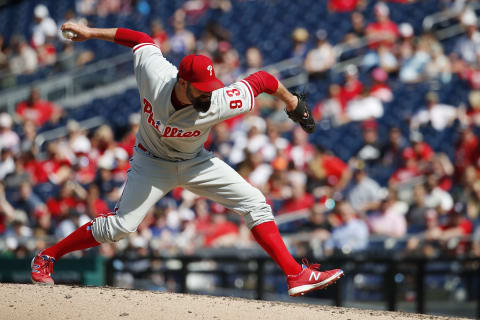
top-left (0, 0), bottom-right (480, 257)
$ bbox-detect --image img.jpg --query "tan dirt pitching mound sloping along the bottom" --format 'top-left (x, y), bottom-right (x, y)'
top-left (0, 283), bottom-right (464, 320)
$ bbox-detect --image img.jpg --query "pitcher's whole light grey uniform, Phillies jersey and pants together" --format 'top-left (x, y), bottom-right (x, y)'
top-left (92, 43), bottom-right (274, 242)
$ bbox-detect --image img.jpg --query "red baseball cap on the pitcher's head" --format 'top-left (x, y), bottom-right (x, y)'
top-left (178, 54), bottom-right (225, 92)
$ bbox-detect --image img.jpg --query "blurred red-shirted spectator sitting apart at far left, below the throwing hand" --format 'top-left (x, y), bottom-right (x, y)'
top-left (17, 88), bottom-right (60, 127)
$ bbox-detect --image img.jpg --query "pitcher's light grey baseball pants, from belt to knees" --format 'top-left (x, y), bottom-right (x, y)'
top-left (92, 147), bottom-right (274, 243)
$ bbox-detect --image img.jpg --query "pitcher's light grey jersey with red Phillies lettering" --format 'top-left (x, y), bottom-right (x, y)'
top-left (133, 43), bottom-right (255, 161)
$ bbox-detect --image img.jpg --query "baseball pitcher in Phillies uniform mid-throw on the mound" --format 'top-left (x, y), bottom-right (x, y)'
top-left (32, 22), bottom-right (343, 296)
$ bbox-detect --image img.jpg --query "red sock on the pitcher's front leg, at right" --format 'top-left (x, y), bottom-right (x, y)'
top-left (251, 221), bottom-right (302, 276)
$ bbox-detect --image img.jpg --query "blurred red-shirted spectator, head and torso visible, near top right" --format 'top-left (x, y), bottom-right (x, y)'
top-left (367, 2), bottom-right (399, 49)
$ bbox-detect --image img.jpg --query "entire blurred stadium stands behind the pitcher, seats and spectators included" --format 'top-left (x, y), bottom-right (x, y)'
top-left (0, 0), bottom-right (480, 317)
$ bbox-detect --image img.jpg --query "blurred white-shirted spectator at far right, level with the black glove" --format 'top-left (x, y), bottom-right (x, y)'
top-left (410, 91), bottom-right (458, 131)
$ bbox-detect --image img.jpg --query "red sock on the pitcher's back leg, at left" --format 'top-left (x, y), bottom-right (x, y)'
top-left (43, 221), bottom-right (100, 260)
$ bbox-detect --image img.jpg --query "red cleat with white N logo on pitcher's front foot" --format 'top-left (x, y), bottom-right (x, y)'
top-left (287, 259), bottom-right (343, 297)
